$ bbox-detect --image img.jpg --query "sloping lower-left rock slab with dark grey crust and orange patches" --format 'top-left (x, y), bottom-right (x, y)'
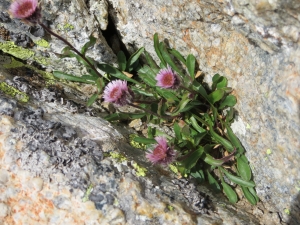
top-left (0, 70), bottom-right (262, 225)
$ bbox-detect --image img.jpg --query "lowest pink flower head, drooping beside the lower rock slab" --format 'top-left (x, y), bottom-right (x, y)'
top-left (146, 137), bottom-right (176, 165)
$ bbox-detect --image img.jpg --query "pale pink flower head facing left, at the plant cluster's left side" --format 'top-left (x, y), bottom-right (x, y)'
top-left (103, 80), bottom-right (133, 106)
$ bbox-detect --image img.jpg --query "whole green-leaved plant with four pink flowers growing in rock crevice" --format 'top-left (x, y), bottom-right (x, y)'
top-left (10, 0), bottom-right (259, 205)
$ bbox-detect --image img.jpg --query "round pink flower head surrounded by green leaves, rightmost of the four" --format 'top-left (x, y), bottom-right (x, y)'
top-left (155, 65), bottom-right (180, 89)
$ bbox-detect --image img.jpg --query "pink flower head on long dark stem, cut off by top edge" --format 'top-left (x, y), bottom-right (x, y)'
top-left (9, 0), bottom-right (41, 23)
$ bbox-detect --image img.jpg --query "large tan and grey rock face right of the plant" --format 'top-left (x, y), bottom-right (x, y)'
top-left (109, 0), bottom-right (300, 224)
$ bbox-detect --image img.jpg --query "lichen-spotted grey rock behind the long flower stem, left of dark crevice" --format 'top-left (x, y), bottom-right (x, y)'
top-left (0, 0), bottom-right (116, 75)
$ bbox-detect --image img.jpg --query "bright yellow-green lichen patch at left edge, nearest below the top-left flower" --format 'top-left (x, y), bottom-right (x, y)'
top-left (0, 41), bottom-right (34, 60)
